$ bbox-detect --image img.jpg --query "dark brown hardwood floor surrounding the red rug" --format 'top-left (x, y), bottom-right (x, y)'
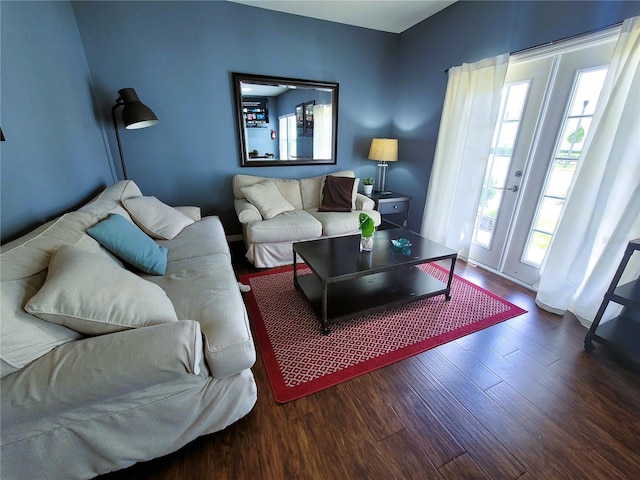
top-left (100, 245), bottom-right (640, 480)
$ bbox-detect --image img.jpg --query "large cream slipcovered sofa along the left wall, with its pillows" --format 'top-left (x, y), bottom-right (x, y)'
top-left (0, 181), bottom-right (256, 480)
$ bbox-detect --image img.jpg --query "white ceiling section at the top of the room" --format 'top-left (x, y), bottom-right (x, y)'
top-left (228, 0), bottom-right (456, 33)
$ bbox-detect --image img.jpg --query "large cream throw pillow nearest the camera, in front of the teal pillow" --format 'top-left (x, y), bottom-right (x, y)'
top-left (24, 245), bottom-right (178, 335)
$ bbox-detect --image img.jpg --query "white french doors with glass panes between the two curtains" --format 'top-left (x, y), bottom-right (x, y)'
top-left (469, 30), bottom-right (616, 285)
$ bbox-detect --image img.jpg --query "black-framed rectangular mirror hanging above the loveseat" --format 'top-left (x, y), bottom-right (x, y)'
top-left (233, 73), bottom-right (338, 167)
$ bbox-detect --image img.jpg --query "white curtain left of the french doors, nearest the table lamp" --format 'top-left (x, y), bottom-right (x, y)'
top-left (421, 54), bottom-right (509, 258)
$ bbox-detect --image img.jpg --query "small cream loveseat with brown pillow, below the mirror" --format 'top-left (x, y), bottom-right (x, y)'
top-left (233, 170), bottom-right (380, 268)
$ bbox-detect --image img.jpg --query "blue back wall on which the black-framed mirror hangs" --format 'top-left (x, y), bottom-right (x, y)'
top-left (73, 2), bottom-right (397, 234)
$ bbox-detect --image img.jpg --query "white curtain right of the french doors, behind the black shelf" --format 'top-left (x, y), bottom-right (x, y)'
top-left (536, 17), bottom-right (640, 326)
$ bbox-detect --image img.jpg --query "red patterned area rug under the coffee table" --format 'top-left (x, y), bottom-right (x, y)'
top-left (240, 264), bottom-right (526, 403)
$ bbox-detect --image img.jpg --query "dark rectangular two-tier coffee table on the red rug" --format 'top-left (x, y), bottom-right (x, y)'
top-left (293, 228), bottom-right (458, 334)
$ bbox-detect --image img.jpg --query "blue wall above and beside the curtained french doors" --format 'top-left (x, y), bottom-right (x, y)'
top-left (396, 1), bottom-right (640, 230)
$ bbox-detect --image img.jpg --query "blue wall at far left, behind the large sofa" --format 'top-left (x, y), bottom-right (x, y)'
top-left (0, 1), bottom-right (114, 241)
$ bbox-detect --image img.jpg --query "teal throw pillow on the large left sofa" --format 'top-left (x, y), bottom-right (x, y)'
top-left (87, 214), bottom-right (168, 275)
